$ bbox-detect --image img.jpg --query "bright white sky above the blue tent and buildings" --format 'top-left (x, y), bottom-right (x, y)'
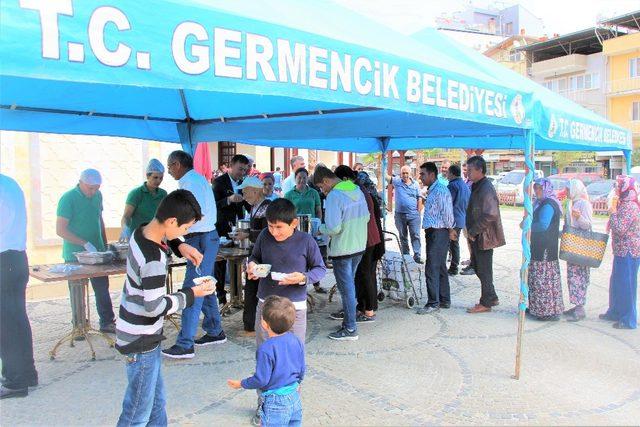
top-left (334, 0), bottom-right (640, 36)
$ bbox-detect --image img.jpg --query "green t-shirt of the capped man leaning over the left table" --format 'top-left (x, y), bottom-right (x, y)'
top-left (56, 186), bottom-right (105, 262)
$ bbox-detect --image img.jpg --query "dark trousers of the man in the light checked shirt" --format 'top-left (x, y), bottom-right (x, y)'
top-left (424, 228), bottom-right (451, 307)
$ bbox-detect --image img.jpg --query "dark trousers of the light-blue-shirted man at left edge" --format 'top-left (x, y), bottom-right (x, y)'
top-left (0, 250), bottom-right (38, 389)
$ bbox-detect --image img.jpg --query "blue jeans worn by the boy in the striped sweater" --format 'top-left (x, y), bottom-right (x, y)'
top-left (118, 346), bottom-right (167, 427)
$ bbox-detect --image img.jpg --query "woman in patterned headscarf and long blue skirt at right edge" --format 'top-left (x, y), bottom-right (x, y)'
top-left (600, 175), bottom-right (640, 329)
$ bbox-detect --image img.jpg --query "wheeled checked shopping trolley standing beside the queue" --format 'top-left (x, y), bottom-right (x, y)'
top-left (377, 230), bottom-right (424, 308)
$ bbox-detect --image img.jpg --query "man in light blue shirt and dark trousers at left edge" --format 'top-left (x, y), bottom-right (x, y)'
top-left (0, 174), bottom-right (38, 399)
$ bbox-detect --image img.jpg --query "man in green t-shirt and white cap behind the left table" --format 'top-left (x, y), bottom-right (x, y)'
top-left (56, 169), bottom-right (115, 333)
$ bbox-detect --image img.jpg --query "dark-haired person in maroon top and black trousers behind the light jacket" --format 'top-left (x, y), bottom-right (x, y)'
top-left (335, 165), bottom-right (384, 323)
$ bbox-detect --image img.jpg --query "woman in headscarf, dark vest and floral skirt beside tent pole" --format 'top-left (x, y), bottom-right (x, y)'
top-left (529, 178), bottom-right (564, 320)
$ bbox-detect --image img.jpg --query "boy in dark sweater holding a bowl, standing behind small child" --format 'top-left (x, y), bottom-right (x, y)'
top-left (247, 199), bottom-right (327, 347)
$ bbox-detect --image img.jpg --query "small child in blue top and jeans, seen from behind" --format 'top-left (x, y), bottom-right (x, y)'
top-left (227, 296), bottom-right (305, 426)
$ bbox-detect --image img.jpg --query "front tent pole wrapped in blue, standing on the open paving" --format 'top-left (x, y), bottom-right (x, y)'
top-left (513, 129), bottom-right (535, 380)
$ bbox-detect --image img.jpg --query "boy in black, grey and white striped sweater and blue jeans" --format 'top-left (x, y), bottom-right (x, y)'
top-left (116, 190), bottom-right (215, 426)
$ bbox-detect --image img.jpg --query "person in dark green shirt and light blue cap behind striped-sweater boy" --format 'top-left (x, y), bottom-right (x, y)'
top-left (120, 159), bottom-right (167, 242)
